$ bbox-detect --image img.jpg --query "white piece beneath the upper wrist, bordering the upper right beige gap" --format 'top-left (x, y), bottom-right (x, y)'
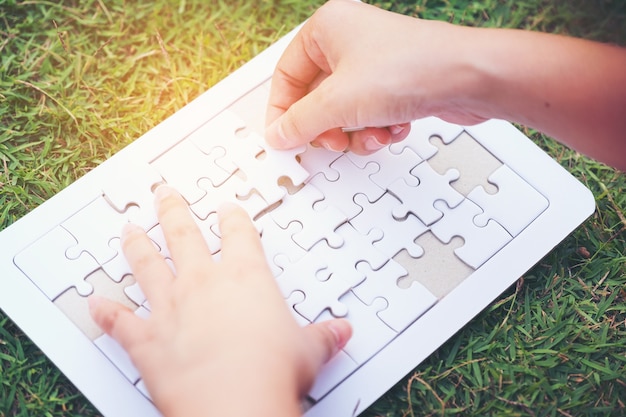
top-left (389, 117), bottom-right (463, 160)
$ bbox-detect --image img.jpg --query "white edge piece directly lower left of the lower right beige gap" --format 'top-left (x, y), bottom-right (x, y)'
top-left (352, 260), bottom-right (437, 333)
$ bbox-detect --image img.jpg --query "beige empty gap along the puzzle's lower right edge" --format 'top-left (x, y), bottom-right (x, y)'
top-left (393, 232), bottom-right (474, 299)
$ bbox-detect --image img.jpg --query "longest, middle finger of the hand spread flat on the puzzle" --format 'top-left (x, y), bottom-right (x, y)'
top-left (155, 186), bottom-right (211, 276)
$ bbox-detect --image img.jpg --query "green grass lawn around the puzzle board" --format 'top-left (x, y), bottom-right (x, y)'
top-left (0, 0), bottom-right (626, 417)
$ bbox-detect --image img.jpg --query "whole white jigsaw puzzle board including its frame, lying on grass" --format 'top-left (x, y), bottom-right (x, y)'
top-left (0, 22), bottom-right (594, 417)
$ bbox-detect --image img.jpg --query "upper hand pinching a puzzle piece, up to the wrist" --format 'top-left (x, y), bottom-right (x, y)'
top-left (266, 0), bottom-right (484, 154)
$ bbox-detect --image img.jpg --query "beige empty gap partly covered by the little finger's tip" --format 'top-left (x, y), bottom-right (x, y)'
top-left (54, 269), bottom-right (138, 340)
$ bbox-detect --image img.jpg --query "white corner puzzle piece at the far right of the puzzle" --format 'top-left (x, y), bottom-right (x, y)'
top-left (467, 165), bottom-right (548, 236)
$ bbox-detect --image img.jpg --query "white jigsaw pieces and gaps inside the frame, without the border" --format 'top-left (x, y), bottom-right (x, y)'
top-left (9, 76), bottom-right (548, 401)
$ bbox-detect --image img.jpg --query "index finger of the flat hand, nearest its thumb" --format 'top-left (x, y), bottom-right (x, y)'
top-left (217, 203), bottom-right (271, 275)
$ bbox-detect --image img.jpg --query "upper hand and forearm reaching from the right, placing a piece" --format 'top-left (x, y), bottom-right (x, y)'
top-left (265, 0), bottom-right (626, 170)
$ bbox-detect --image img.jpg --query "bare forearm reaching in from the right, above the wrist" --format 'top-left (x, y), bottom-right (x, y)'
top-left (436, 24), bottom-right (626, 171)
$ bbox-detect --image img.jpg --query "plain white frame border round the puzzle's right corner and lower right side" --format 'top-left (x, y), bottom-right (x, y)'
top-left (305, 120), bottom-right (595, 417)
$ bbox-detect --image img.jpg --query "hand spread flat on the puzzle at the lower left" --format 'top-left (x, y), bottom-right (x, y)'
top-left (90, 186), bottom-right (351, 416)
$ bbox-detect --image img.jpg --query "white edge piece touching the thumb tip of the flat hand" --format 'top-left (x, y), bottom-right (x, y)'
top-left (315, 291), bottom-right (397, 365)
